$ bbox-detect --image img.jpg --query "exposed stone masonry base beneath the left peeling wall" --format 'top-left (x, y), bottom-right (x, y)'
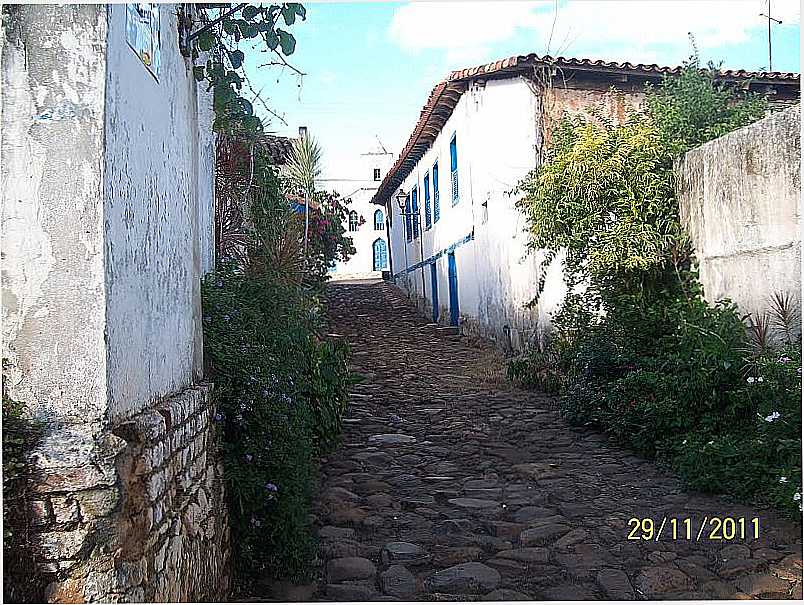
top-left (31, 384), bottom-right (229, 602)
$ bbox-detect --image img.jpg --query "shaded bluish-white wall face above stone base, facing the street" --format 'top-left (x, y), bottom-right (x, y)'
top-left (104, 4), bottom-right (213, 419)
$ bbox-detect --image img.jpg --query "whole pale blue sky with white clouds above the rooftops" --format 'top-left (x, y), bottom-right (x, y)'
top-left (244, 0), bottom-right (800, 179)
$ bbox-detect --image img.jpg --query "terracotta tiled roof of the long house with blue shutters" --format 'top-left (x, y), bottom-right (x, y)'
top-left (371, 53), bottom-right (800, 205)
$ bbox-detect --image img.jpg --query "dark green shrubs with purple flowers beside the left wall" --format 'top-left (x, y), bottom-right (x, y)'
top-left (202, 137), bottom-right (349, 589)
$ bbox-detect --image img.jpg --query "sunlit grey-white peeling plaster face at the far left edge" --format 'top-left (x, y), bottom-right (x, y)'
top-left (2, 5), bottom-right (106, 424)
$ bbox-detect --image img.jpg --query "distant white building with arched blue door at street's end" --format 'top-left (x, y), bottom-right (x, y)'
top-left (320, 142), bottom-right (393, 279)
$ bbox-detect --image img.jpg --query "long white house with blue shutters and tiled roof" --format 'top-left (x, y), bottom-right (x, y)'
top-left (371, 54), bottom-right (798, 351)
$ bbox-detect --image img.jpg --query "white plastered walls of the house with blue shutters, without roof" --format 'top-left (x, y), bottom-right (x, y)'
top-left (391, 77), bottom-right (639, 351)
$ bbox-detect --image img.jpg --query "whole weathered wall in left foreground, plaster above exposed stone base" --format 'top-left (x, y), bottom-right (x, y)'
top-left (0, 5), bottom-right (228, 602)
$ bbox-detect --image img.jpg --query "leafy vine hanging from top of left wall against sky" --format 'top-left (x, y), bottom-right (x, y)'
top-left (179, 2), bottom-right (307, 139)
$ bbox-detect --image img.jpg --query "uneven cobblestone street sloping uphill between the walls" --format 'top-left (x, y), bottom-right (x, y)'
top-left (306, 283), bottom-right (802, 601)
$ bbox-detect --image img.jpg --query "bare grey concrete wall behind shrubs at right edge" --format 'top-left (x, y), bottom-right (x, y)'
top-left (676, 105), bottom-right (801, 313)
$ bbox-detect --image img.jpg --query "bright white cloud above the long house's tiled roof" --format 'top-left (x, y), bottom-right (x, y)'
top-left (388, 0), bottom-right (800, 65)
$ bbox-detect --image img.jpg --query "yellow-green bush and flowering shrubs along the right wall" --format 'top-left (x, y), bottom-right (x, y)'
top-left (509, 53), bottom-right (801, 514)
